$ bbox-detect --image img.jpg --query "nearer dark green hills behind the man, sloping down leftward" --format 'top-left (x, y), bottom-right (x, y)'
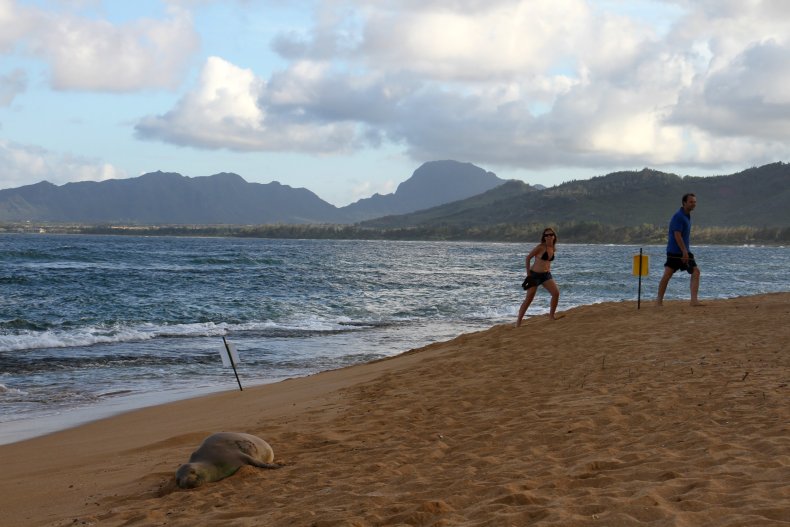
top-left (361, 162), bottom-right (790, 229)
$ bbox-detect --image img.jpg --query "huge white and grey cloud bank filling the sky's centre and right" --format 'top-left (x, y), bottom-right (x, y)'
top-left (137, 0), bottom-right (790, 173)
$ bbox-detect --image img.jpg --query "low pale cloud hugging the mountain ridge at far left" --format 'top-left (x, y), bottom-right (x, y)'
top-left (0, 139), bottom-right (127, 188)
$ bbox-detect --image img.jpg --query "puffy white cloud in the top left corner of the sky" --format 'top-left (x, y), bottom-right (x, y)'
top-left (0, 0), bottom-right (200, 92)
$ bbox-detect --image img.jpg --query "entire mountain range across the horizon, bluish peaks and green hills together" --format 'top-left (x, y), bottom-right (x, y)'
top-left (0, 160), bottom-right (790, 229)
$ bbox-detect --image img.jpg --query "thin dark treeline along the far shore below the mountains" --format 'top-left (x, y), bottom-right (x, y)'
top-left (0, 222), bottom-right (790, 245)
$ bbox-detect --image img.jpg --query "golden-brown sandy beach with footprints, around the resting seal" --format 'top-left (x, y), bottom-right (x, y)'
top-left (0, 293), bottom-right (790, 527)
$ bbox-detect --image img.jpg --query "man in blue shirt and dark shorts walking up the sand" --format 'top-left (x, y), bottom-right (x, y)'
top-left (656, 194), bottom-right (702, 306)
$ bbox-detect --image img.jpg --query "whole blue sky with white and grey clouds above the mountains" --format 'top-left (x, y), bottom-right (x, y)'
top-left (0, 0), bottom-right (790, 206)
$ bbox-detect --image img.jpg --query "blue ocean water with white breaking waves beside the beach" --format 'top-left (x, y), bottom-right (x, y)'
top-left (0, 233), bottom-right (790, 444)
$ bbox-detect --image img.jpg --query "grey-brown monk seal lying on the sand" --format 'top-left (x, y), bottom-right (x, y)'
top-left (176, 432), bottom-right (282, 489)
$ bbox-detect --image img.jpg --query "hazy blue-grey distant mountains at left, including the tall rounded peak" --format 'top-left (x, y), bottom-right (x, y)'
top-left (0, 160), bottom-right (505, 225)
